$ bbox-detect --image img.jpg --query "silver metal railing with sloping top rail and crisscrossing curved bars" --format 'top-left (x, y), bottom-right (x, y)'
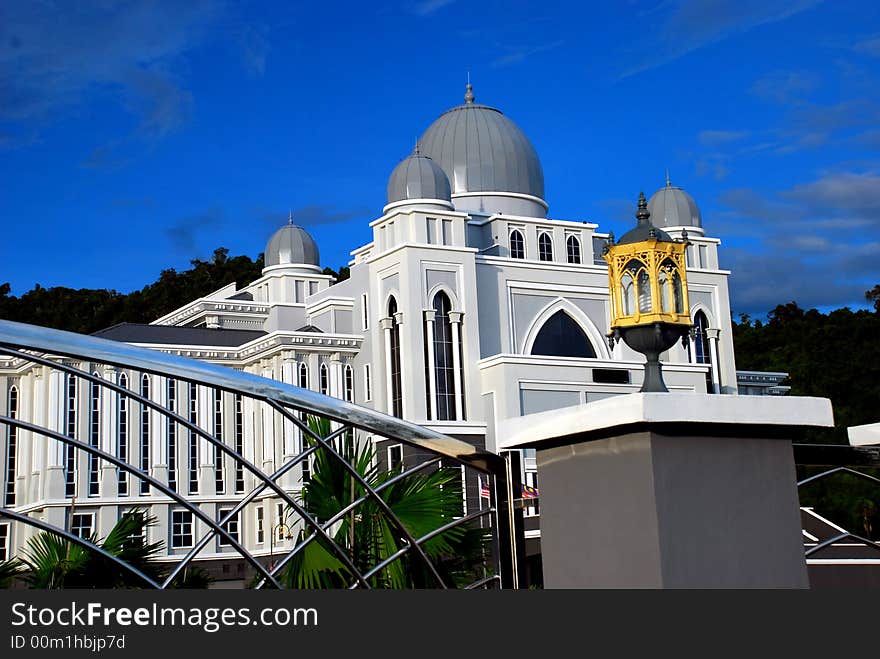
top-left (0, 321), bottom-right (517, 588)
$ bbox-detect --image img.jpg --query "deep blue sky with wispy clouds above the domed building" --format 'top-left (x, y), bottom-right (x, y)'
top-left (0, 0), bottom-right (880, 315)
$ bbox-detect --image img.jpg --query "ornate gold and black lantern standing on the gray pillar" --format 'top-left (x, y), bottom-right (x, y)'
top-left (602, 192), bottom-right (691, 392)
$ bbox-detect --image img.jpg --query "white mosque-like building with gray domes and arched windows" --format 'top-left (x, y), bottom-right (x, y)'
top-left (0, 85), bottom-right (768, 580)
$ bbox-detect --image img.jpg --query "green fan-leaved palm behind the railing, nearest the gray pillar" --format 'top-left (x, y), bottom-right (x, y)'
top-left (280, 417), bottom-right (485, 588)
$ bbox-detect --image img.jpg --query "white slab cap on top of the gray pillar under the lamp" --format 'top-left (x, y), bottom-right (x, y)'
top-left (497, 393), bottom-right (836, 449)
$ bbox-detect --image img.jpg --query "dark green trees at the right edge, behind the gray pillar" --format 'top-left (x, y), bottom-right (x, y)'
top-left (733, 300), bottom-right (880, 444)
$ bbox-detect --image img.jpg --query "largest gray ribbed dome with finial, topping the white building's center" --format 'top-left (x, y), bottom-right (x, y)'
top-left (419, 85), bottom-right (544, 200)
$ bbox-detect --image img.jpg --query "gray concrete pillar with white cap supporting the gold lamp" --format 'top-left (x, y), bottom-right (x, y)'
top-left (498, 393), bottom-right (833, 588)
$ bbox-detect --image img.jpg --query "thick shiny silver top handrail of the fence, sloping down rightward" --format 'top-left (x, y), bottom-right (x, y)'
top-left (0, 320), bottom-right (499, 472)
